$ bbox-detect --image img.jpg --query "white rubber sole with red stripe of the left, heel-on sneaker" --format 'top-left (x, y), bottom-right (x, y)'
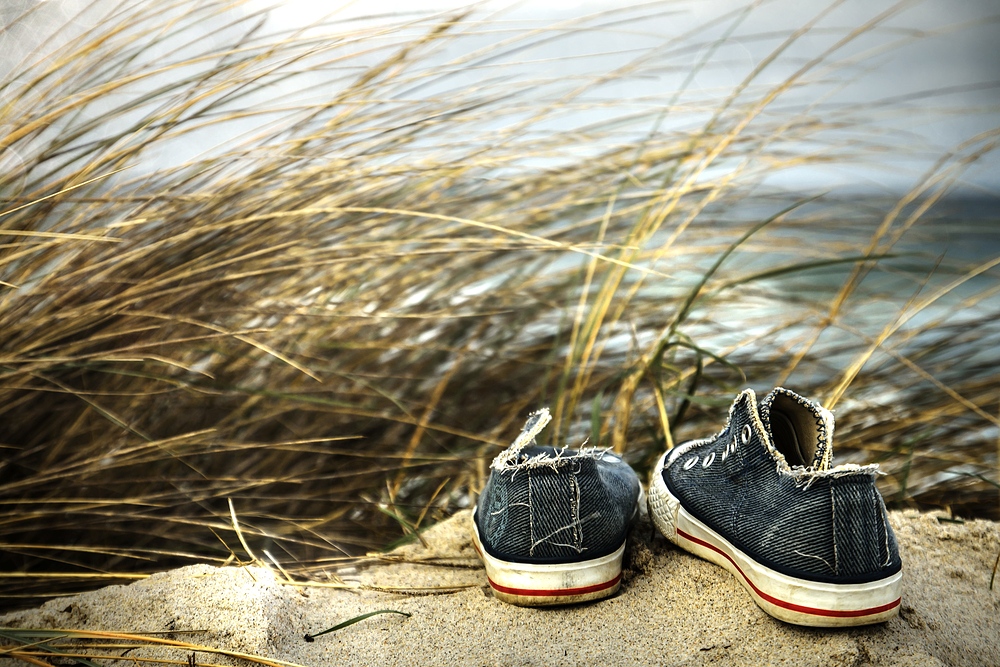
top-left (471, 510), bottom-right (625, 607)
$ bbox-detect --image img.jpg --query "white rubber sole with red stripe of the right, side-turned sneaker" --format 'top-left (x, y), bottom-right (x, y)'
top-left (649, 454), bottom-right (902, 627)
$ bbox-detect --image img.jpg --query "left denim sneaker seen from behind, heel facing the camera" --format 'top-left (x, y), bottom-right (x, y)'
top-left (472, 409), bottom-right (641, 607)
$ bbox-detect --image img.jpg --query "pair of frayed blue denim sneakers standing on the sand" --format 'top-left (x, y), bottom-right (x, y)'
top-left (472, 387), bottom-right (902, 627)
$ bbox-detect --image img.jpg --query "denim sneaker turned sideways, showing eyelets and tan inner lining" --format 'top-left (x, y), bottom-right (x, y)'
top-left (649, 387), bottom-right (902, 627)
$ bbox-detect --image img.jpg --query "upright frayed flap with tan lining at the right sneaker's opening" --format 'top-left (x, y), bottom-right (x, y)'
top-left (760, 387), bottom-right (833, 470)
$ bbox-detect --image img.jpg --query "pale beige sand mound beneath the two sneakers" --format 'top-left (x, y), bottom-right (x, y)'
top-left (0, 512), bottom-right (1000, 667)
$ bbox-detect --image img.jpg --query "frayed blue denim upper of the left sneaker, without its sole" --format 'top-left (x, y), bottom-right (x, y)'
top-left (475, 410), bottom-right (639, 563)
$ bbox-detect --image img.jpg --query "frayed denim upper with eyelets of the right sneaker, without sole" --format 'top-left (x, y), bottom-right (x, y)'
top-left (663, 388), bottom-right (901, 584)
